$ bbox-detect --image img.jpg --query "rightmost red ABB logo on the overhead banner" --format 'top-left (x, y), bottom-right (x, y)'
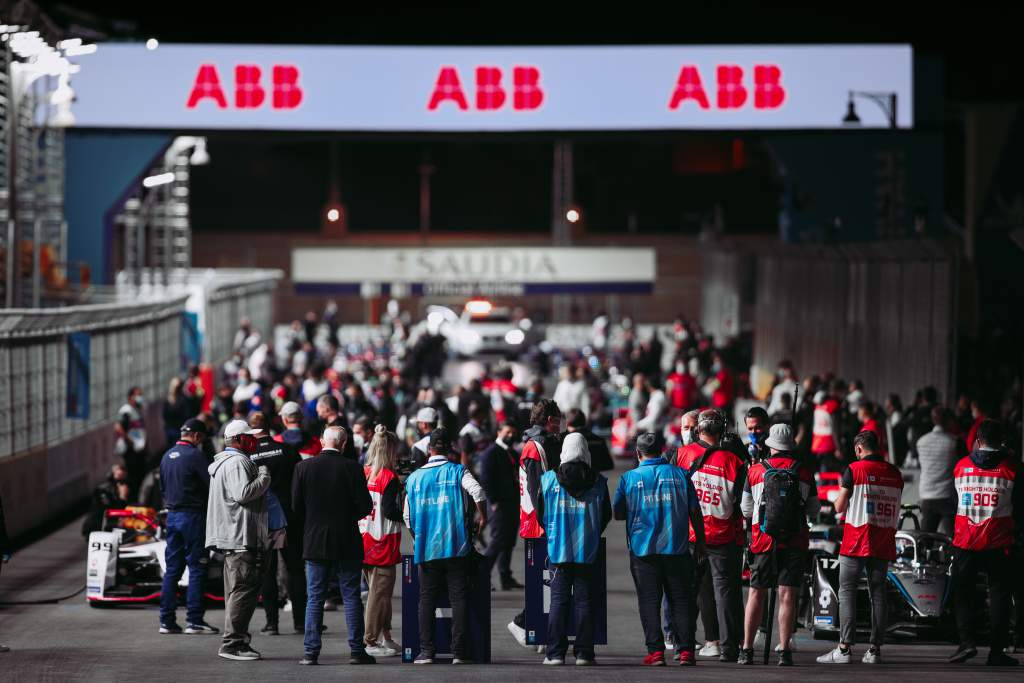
top-left (669, 65), bottom-right (785, 110)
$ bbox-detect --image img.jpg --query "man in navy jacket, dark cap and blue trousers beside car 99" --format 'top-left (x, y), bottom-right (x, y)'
top-left (160, 419), bottom-right (218, 634)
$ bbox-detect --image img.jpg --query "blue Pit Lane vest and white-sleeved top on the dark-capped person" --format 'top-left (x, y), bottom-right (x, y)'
top-left (404, 456), bottom-right (485, 564)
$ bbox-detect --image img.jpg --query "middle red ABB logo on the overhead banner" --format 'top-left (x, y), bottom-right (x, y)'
top-left (427, 67), bottom-right (544, 112)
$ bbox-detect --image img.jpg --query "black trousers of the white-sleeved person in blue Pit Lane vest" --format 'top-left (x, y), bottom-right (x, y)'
top-left (420, 557), bottom-right (469, 659)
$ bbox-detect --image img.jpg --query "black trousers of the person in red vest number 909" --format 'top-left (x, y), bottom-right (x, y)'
top-left (952, 548), bottom-right (1014, 652)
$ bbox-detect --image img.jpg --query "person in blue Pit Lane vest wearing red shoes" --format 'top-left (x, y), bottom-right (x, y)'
top-left (612, 432), bottom-right (705, 667)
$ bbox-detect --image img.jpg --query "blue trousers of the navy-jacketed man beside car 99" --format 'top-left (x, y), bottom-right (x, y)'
top-left (160, 510), bottom-right (210, 625)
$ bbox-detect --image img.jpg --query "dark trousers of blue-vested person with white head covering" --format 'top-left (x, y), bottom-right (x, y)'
top-left (548, 562), bottom-right (594, 659)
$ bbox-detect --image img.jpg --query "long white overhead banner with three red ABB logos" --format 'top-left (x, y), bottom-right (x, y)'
top-left (66, 43), bottom-right (913, 131)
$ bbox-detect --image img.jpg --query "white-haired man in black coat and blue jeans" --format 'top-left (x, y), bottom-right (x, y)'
top-left (292, 427), bottom-right (377, 665)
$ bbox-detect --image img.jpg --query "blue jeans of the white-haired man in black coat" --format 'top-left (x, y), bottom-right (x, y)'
top-left (303, 560), bottom-right (367, 657)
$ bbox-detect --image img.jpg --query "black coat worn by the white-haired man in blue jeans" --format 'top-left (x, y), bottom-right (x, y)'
top-left (292, 449), bottom-right (374, 562)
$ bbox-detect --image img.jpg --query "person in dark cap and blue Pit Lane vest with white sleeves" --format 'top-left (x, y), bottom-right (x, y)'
top-left (404, 428), bottom-right (487, 665)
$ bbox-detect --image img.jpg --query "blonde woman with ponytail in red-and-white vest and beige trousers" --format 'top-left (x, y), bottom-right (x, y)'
top-left (359, 425), bottom-right (403, 657)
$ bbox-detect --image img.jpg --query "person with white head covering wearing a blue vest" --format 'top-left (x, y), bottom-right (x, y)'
top-left (539, 432), bottom-right (611, 667)
